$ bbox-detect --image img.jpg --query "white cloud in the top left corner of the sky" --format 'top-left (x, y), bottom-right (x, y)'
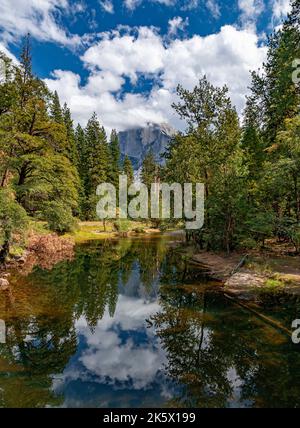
top-left (0, 0), bottom-right (81, 46)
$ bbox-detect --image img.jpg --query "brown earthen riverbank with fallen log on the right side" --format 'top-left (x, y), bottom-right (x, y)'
top-left (180, 241), bottom-right (300, 300)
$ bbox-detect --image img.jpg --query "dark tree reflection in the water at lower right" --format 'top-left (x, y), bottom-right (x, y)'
top-left (151, 270), bottom-right (300, 408)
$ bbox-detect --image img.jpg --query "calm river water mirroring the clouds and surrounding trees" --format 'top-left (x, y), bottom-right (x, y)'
top-left (0, 237), bottom-right (300, 407)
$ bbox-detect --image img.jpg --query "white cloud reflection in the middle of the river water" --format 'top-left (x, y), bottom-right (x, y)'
top-left (64, 295), bottom-right (166, 390)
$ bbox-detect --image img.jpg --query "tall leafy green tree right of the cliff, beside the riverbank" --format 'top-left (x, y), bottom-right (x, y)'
top-left (163, 77), bottom-right (248, 251)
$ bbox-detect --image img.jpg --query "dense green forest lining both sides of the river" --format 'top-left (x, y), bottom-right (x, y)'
top-left (0, 0), bottom-right (300, 262)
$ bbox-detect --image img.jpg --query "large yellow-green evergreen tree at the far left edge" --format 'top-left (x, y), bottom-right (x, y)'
top-left (0, 38), bottom-right (78, 226)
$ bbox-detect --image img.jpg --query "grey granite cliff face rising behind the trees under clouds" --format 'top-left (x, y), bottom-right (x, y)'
top-left (119, 124), bottom-right (175, 169)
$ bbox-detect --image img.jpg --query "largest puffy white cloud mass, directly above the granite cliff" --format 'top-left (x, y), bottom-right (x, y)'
top-left (46, 25), bottom-right (266, 130)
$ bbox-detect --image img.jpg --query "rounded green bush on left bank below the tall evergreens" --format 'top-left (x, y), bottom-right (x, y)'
top-left (43, 202), bottom-right (77, 233)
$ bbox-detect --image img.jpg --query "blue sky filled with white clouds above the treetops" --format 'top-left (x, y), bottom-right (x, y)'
top-left (0, 0), bottom-right (289, 130)
